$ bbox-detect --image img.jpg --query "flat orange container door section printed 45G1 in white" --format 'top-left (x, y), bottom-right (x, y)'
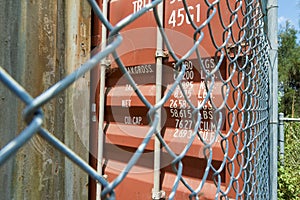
top-left (164, 0), bottom-right (234, 59)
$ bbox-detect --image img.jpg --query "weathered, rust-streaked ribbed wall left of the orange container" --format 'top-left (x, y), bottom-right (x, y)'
top-left (0, 0), bottom-right (90, 199)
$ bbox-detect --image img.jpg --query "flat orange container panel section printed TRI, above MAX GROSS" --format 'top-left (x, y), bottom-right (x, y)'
top-left (109, 0), bottom-right (156, 66)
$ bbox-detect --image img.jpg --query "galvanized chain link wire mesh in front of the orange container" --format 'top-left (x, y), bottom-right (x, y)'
top-left (0, 0), bottom-right (270, 199)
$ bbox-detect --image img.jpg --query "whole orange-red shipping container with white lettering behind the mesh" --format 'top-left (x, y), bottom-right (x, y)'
top-left (90, 0), bottom-right (245, 200)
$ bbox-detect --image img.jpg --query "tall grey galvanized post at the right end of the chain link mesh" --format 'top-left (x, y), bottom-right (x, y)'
top-left (267, 0), bottom-right (278, 200)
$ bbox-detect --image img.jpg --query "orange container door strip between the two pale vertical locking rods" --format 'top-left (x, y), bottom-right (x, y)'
top-left (103, 0), bottom-right (157, 199)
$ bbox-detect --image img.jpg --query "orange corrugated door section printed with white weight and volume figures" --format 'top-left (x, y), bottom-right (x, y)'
top-left (162, 57), bottom-right (227, 199)
